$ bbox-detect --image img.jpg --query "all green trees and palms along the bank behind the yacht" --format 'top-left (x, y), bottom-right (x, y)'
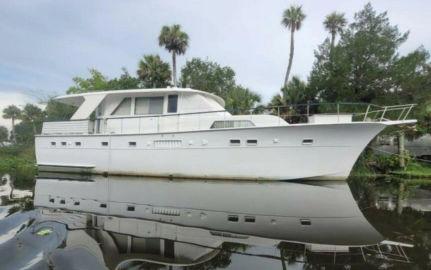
top-left (0, 3), bottom-right (431, 188)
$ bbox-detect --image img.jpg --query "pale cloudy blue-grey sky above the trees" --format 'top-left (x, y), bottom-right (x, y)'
top-left (0, 0), bottom-right (431, 125)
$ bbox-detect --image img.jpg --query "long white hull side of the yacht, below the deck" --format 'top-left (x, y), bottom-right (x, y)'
top-left (36, 122), bottom-right (390, 180)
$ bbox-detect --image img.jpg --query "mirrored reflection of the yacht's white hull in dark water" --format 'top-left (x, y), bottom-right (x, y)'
top-left (35, 176), bottom-right (382, 246)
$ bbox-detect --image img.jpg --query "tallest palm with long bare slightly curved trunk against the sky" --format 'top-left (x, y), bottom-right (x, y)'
top-left (281, 6), bottom-right (305, 85)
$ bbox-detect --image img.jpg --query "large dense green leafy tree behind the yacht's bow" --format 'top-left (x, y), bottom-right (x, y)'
top-left (309, 4), bottom-right (408, 103)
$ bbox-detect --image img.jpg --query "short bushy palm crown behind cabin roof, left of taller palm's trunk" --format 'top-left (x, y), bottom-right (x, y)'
top-left (137, 55), bottom-right (171, 88)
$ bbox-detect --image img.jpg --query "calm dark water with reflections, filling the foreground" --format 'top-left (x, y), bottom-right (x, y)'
top-left (0, 175), bottom-right (431, 269)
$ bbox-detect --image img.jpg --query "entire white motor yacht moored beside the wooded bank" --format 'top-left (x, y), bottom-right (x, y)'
top-left (36, 88), bottom-right (415, 180)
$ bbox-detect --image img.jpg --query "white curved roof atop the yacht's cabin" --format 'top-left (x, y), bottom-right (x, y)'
top-left (55, 87), bottom-right (225, 107)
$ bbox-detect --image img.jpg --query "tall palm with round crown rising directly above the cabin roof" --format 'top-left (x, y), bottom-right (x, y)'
top-left (159, 24), bottom-right (189, 86)
